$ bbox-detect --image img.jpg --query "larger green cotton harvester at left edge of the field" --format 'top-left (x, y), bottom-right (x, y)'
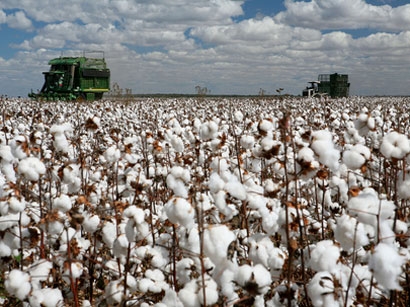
top-left (28, 51), bottom-right (110, 101)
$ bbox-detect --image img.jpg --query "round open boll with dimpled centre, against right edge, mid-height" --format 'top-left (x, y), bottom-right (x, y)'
top-left (380, 131), bottom-right (410, 159)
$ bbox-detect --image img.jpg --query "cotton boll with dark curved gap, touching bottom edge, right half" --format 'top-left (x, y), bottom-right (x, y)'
top-left (308, 272), bottom-right (340, 307)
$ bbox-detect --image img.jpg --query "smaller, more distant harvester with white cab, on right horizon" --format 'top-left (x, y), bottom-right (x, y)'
top-left (302, 73), bottom-right (350, 98)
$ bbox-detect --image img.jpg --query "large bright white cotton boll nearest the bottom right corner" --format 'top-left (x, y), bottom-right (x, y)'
top-left (369, 243), bottom-right (406, 290)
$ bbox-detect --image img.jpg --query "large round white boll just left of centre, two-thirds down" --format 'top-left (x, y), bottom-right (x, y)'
top-left (164, 197), bottom-right (195, 228)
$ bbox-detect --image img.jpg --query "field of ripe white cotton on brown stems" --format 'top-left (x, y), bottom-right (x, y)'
top-left (0, 97), bottom-right (410, 307)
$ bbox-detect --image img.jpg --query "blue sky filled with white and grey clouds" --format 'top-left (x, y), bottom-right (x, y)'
top-left (0, 0), bottom-right (410, 97)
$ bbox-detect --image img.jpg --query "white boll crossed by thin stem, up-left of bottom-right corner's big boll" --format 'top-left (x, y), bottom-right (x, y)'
top-left (334, 214), bottom-right (369, 251)
